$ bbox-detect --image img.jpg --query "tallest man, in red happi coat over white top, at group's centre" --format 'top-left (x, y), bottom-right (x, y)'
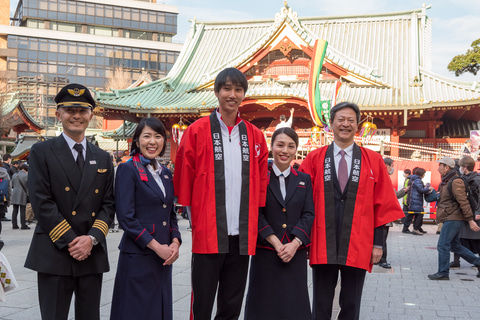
top-left (174, 68), bottom-right (268, 320)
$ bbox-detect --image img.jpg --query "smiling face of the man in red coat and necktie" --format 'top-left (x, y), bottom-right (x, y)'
top-left (331, 108), bottom-right (357, 146)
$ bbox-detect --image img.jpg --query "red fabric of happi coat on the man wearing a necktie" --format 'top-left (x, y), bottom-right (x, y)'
top-left (300, 146), bottom-right (404, 272)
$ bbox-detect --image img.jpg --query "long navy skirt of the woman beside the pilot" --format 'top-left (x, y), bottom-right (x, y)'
top-left (110, 251), bottom-right (173, 320)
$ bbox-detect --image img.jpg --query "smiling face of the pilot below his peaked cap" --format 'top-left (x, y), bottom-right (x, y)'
top-left (55, 107), bottom-right (93, 142)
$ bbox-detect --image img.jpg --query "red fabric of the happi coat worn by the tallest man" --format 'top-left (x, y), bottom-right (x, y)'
top-left (174, 115), bottom-right (268, 255)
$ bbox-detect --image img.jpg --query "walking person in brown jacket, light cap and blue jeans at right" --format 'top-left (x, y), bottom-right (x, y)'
top-left (428, 157), bottom-right (480, 280)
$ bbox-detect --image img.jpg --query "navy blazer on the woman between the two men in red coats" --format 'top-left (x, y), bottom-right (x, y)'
top-left (257, 169), bottom-right (315, 249)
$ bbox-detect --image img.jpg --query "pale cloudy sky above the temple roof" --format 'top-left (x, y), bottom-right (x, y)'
top-left (11, 0), bottom-right (480, 81)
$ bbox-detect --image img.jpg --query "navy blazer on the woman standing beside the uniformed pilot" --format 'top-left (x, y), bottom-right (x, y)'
top-left (115, 161), bottom-right (181, 254)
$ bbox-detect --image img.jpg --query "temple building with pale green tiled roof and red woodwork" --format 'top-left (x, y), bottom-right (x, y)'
top-left (96, 2), bottom-right (480, 160)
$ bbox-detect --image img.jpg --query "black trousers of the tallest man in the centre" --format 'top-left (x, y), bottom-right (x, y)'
top-left (190, 236), bottom-right (250, 320)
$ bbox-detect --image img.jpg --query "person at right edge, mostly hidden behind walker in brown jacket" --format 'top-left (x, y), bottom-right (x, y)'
top-left (450, 157), bottom-right (480, 272)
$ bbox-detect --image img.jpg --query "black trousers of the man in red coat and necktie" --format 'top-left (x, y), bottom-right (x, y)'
top-left (312, 264), bottom-right (366, 320)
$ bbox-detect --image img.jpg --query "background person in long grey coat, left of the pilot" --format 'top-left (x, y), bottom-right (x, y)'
top-left (12, 164), bottom-right (30, 230)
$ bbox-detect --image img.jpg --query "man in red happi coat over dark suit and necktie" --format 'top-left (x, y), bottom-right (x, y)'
top-left (300, 102), bottom-right (404, 320)
